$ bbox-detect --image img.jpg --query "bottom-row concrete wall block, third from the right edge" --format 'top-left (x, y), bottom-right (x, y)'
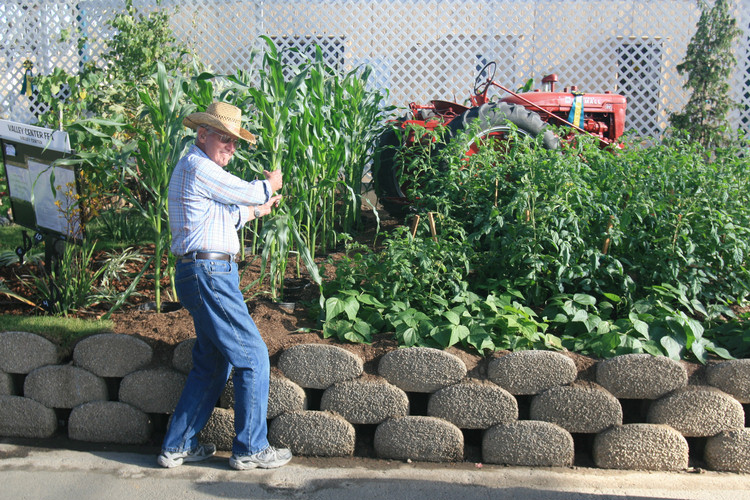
top-left (482, 420), bottom-right (575, 467)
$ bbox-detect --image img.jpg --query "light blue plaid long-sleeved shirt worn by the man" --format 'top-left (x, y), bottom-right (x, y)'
top-left (169, 145), bottom-right (271, 256)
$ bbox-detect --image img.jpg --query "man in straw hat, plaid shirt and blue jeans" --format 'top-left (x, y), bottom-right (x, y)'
top-left (157, 102), bottom-right (292, 470)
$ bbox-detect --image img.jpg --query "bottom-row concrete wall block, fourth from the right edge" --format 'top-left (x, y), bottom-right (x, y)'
top-left (375, 416), bottom-right (464, 462)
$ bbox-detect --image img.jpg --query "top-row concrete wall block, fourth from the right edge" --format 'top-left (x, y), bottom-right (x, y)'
top-left (378, 347), bottom-right (467, 393)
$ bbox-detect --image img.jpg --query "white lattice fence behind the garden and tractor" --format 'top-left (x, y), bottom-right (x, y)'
top-left (0, 0), bottom-right (750, 134)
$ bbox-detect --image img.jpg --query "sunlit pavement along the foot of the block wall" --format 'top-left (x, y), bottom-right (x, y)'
top-left (0, 441), bottom-right (750, 500)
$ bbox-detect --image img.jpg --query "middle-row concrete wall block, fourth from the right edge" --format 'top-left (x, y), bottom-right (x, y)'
top-left (320, 379), bottom-right (409, 424)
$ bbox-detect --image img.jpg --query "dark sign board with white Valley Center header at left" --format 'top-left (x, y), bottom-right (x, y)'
top-left (0, 120), bottom-right (83, 239)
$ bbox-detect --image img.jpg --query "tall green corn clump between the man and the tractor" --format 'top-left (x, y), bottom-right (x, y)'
top-left (224, 37), bottom-right (383, 298)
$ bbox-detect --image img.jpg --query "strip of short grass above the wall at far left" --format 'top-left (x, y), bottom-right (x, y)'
top-left (0, 314), bottom-right (114, 349)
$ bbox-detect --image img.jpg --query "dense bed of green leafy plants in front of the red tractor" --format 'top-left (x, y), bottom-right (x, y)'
top-left (322, 120), bottom-right (750, 362)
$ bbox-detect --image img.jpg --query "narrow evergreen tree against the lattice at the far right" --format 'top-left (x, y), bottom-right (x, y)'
top-left (670, 0), bottom-right (741, 146)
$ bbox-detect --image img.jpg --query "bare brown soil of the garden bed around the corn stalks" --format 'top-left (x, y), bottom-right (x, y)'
top-left (0, 207), bottom-right (482, 374)
